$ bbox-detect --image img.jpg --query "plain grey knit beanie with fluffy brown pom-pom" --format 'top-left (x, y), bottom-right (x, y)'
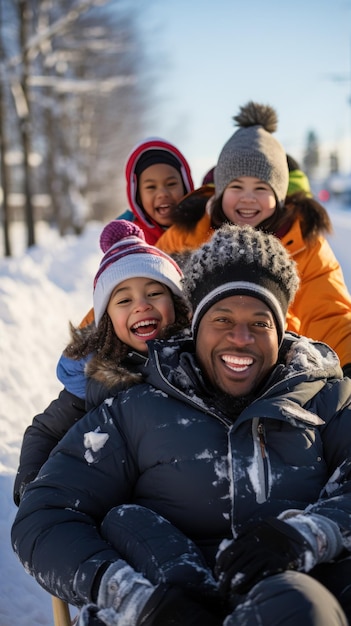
top-left (214, 102), bottom-right (289, 205)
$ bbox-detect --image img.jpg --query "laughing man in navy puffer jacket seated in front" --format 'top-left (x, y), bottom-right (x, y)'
top-left (12, 225), bottom-right (351, 626)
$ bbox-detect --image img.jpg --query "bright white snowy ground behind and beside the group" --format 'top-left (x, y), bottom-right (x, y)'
top-left (0, 205), bottom-right (351, 626)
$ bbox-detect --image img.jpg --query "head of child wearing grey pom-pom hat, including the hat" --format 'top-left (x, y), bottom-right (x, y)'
top-left (211, 102), bottom-right (296, 230)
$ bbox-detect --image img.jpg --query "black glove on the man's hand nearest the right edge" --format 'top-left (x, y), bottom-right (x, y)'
top-left (215, 518), bottom-right (310, 596)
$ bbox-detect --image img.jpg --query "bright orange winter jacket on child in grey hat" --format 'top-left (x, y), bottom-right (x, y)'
top-left (156, 213), bottom-right (351, 366)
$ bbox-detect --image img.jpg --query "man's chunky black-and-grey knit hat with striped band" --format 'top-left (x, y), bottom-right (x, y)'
top-left (182, 224), bottom-right (299, 343)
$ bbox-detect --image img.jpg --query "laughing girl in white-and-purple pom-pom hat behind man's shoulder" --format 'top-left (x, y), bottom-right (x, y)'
top-left (14, 220), bottom-right (189, 505)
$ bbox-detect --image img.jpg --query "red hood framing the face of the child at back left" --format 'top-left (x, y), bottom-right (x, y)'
top-left (124, 137), bottom-right (194, 245)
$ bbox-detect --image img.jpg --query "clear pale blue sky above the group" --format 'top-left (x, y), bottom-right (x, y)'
top-left (143, 0), bottom-right (351, 184)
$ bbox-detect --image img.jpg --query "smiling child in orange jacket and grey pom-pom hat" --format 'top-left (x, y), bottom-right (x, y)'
top-left (156, 102), bottom-right (351, 376)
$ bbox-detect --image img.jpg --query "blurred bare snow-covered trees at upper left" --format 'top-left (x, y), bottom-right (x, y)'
top-left (0, 0), bottom-right (156, 254)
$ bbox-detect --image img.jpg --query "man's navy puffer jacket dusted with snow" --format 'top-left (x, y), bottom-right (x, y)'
top-left (12, 335), bottom-right (351, 606)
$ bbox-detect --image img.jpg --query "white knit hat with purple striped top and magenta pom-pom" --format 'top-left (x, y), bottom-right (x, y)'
top-left (93, 220), bottom-right (183, 326)
